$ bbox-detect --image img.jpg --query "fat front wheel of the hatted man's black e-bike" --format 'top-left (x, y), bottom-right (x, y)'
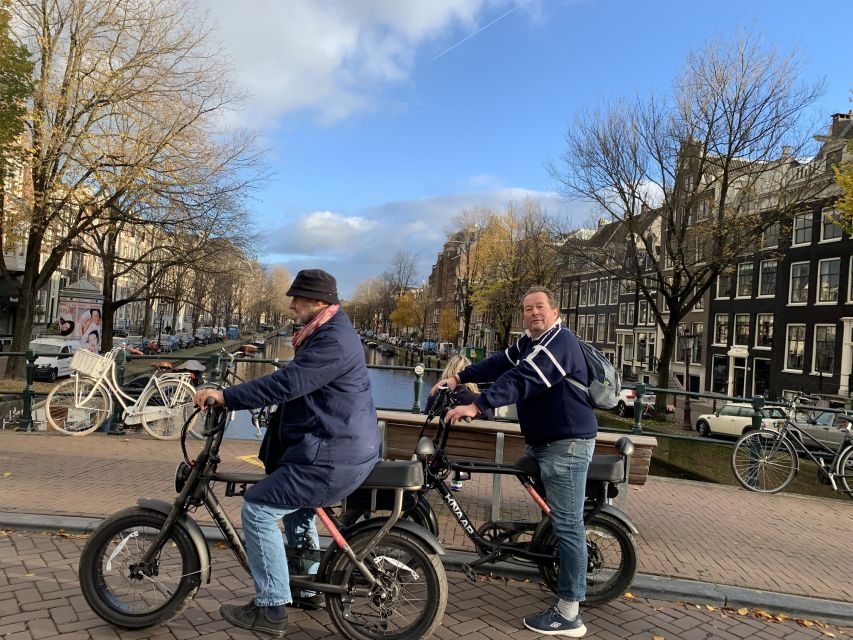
top-left (79, 507), bottom-right (201, 629)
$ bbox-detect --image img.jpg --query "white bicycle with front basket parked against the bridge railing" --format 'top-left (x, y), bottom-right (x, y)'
top-left (45, 347), bottom-right (200, 440)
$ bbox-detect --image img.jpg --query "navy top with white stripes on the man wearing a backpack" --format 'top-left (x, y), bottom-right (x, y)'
top-left (459, 319), bottom-right (598, 446)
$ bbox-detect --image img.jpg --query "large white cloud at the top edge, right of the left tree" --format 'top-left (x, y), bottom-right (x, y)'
top-left (206, 0), bottom-right (524, 127)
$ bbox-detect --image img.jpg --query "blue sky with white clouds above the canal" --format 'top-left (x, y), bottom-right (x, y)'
top-left (201, 0), bottom-right (853, 295)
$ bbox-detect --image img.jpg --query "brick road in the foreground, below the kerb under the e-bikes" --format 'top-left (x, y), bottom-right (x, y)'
top-left (0, 531), bottom-right (853, 640)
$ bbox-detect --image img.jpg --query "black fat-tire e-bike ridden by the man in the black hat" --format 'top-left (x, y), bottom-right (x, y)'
top-left (79, 402), bottom-right (447, 640)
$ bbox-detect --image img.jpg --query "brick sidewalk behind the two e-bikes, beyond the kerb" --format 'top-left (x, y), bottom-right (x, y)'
top-left (0, 431), bottom-right (853, 602)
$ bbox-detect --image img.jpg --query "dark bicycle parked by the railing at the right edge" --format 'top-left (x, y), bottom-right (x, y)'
top-left (731, 398), bottom-right (853, 498)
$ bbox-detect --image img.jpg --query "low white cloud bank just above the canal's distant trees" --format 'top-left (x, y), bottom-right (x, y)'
top-left (264, 188), bottom-right (590, 296)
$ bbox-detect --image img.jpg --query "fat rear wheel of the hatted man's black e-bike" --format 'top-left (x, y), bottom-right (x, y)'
top-left (323, 529), bottom-right (447, 640)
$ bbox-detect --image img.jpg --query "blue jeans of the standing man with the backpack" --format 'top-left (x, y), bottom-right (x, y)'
top-left (527, 438), bottom-right (595, 602)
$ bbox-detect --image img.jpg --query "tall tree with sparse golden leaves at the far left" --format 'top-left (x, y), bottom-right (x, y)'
top-left (3, 0), bottom-right (257, 373)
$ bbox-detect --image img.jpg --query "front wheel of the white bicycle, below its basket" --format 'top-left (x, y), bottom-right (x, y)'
top-left (44, 375), bottom-right (112, 436)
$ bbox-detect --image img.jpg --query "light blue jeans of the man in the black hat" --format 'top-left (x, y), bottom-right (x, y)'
top-left (242, 500), bottom-right (320, 607)
